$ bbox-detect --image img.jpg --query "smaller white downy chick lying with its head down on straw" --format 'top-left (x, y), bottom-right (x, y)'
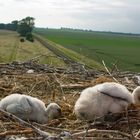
top-left (0, 93), bottom-right (61, 123)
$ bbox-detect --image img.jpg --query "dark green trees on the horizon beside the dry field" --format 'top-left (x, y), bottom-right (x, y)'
top-left (0, 17), bottom-right (35, 42)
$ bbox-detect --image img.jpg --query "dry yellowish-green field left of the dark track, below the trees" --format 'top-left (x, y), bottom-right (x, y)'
top-left (0, 30), bottom-right (65, 66)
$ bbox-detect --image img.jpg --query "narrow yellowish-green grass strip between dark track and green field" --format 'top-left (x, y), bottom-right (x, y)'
top-left (34, 34), bottom-right (104, 70)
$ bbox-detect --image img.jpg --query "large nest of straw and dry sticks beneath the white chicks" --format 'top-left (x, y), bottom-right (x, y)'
top-left (0, 62), bottom-right (140, 140)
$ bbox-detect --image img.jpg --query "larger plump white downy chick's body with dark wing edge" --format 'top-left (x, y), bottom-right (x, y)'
top-left (74, 82), bottom-right (133, 120)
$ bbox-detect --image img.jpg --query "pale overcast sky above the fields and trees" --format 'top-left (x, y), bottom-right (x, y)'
top-left (0, 0), bottom-right (140, 33)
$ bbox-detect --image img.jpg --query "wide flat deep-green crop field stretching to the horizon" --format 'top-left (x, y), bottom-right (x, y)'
top-left (35, 29), bottom-right (140, 72)
